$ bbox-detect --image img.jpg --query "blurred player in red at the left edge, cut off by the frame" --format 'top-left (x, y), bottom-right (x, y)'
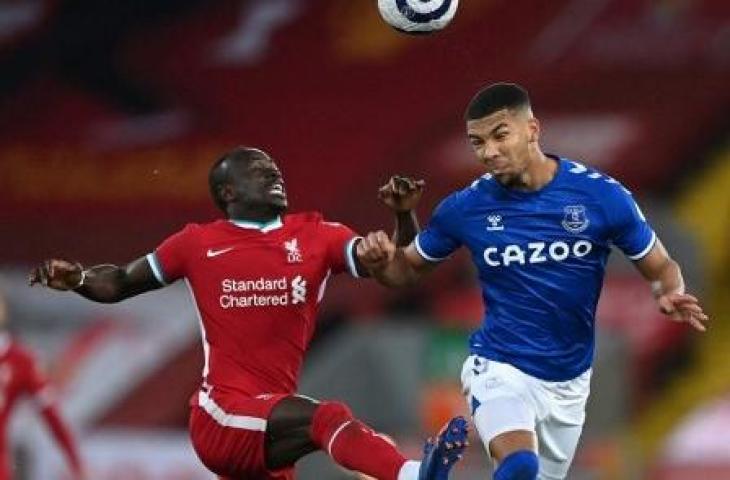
top-left (0, 295), bottom-right (85, 480)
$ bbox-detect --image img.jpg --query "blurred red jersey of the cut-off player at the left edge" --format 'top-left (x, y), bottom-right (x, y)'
top-left (0, 333), bottom-right (52, 479)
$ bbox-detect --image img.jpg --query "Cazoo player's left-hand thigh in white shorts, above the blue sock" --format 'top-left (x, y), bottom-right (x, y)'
top-left (462, 357), bottom-right (537, 462)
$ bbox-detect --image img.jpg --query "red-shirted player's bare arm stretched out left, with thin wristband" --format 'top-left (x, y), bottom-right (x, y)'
top-left (28, 257), bottom-right (162, 303)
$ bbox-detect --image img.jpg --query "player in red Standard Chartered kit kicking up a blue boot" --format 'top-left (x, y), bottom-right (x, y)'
top-left (29, 147), bottom-right (466, 480)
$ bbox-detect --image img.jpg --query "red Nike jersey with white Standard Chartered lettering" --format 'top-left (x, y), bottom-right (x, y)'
top-left (147, 213), bottom-right (357, 396)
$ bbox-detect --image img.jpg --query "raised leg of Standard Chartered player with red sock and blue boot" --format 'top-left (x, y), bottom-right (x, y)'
top-left (266, 397), bottom-right (466, 480)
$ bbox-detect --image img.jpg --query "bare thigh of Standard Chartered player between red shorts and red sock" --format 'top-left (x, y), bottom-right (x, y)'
top-left (265, 396), bottom-right (319, 469)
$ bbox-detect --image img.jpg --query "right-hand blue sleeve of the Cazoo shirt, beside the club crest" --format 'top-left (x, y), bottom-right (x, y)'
top-left (606, 184), bottom-right (657, 260)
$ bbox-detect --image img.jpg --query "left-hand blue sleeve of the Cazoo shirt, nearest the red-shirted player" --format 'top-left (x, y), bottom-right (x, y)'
top-left (415, 194), bottom-right (461, 262)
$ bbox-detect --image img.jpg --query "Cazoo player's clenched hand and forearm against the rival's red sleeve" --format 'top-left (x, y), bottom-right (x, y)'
top-left (355, 230), bottom-right (435, 287)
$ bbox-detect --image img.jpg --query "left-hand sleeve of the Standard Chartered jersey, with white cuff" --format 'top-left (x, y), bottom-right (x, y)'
top-left (147, 223), bottom-right (200, 285)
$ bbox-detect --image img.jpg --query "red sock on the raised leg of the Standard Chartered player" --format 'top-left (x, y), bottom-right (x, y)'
top-left (311, 402), bottom-right (406, 480)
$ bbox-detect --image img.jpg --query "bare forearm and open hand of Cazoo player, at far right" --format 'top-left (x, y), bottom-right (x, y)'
top-left (635, 240), bottom-right (709, 332)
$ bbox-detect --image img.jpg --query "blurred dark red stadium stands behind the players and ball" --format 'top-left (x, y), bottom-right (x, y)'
top-left (0, 0), bottom-right (730, 480)
